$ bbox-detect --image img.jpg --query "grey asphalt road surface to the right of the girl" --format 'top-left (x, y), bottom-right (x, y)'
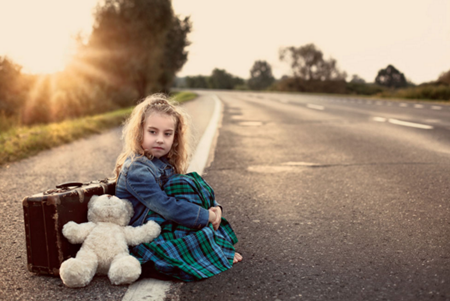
top-left (178, 92), bottom-right (450, 300)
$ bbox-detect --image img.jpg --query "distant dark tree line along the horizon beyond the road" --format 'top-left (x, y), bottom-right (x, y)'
top-left (176, 44), bottom-right (450, 100)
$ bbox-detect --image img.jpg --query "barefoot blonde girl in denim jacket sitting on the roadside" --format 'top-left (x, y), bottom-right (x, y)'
top-left (114, 94), bottom-right (242, 281)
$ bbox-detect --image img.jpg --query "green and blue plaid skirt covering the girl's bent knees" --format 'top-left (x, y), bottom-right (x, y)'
top-left (130, 172), bottom-right (238, 281)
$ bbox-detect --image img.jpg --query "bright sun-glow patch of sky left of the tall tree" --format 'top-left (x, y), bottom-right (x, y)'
top-left (0, 0), bottom-right (98, 74)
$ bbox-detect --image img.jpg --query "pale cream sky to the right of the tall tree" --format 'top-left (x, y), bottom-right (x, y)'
top-left (172, 0), bottom-right (450, 83)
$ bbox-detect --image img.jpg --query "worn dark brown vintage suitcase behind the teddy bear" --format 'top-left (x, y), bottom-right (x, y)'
top-left (22, 179), bottom-right (116, 276)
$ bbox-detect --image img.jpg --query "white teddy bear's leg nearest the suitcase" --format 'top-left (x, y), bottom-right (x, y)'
top-left (59, 248), bottom-right (98, 287)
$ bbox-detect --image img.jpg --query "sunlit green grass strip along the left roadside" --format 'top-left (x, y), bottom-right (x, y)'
top-left (0, 92), bottom-right (197, 166)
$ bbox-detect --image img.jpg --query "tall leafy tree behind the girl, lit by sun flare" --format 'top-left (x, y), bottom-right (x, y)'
top-left (81, 0), bottom-right (191, 98)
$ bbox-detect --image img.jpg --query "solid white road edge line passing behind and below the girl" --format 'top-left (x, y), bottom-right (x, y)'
top-left (122, 95), bottom-right (222, 301)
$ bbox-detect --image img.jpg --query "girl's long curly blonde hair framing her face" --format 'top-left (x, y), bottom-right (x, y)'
top-left (114, 94), bottom-right (190, 179)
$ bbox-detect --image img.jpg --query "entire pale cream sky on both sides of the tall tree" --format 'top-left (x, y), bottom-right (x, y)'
top-left (0, 0), bottom-right (450, 84)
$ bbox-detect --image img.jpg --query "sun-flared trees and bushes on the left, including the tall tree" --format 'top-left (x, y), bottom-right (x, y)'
top-left (0, 0), bottom-right (192, 131)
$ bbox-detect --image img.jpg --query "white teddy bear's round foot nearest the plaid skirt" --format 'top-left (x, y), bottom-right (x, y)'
top-left (108, 254), bottom-right (141, 285)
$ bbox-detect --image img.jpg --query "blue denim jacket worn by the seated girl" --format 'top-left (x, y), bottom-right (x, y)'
top-left (116, 157), bottom-right (209, 229)
